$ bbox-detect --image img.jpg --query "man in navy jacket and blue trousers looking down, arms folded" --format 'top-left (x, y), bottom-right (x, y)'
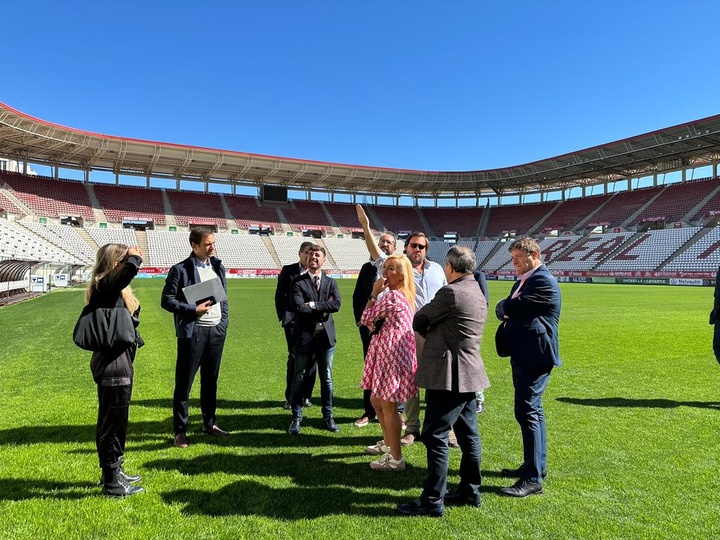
top-left (495, 237), bottom-right (562, 497)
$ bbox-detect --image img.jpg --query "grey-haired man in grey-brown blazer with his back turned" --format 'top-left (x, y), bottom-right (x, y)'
top-left (398, 245), bottom-right (490, 517)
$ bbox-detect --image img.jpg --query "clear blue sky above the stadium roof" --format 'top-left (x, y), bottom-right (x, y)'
top-left (0, 0), bottom-right (720, 170)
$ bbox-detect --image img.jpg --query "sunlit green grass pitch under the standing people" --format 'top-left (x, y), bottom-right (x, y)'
top-left (0, 280), bottom-right (720, 540)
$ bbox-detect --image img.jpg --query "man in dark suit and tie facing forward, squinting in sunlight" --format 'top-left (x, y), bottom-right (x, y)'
top-left (288, 245), bottom-right (340, 435)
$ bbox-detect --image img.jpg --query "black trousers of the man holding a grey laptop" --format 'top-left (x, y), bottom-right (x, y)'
top-left (173, 325), bottom-right (225, 434)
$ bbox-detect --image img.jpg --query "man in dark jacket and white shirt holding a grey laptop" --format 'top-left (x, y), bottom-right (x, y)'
top-left (160, 227), bottom-right (228, 448)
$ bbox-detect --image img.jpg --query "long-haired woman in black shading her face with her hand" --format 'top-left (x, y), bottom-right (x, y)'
top-left (85, 244), bottom-right (145, 497)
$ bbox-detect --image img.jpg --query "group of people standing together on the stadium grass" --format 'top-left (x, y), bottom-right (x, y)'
top-left (81, 220), bottom-right (561, 516)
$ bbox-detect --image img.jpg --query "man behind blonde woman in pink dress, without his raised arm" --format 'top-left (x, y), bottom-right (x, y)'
top-left (353, 231), bottom-right (402, 427)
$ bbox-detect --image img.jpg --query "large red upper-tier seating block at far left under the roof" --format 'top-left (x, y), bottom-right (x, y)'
top-left (0, 171), bottom-right (94, 221)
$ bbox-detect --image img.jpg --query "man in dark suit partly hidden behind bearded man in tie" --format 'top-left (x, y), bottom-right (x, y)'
top-left (275, 242), bottom-right (317, 409)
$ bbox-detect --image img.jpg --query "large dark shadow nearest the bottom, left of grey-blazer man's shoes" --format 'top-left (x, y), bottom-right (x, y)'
top-left (162, 478), bottom-right (407, 521)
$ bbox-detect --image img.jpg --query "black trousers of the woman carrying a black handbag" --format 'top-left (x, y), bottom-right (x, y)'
top-left (90, 347), bottom-right (135, 471)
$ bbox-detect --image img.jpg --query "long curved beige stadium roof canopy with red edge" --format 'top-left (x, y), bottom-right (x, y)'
top-left (0, 103), bottom-right (720, 197)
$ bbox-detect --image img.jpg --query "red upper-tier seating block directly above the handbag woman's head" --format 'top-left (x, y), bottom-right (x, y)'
top-left (93, 184), bottom-right (165, 223)
